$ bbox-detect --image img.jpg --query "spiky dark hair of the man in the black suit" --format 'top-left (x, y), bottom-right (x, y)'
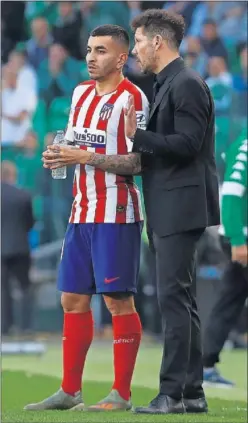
top-left (131, 9), bottom-right (185, 50)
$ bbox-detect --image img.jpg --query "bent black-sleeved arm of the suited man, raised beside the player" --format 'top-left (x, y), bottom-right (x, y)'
top-left (133, 79), bottom-right (210, 159)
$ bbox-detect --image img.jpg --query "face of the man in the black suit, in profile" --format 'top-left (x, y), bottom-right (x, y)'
top-left (132, 28), bottom-right (156, 73)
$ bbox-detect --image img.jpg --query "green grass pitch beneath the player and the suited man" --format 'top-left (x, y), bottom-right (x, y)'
top-left (1, 343), bottom-right (247, 423)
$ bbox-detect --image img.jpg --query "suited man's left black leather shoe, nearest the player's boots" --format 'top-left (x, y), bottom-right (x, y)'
top-left (133, 394), bottom-right (186, 414)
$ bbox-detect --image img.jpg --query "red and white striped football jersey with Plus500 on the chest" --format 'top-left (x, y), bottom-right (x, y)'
top-left (65, 79), bottom-right (149, 223)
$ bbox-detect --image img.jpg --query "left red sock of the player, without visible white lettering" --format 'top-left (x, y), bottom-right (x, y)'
top-left (61, 311), bottom-right (93, 395)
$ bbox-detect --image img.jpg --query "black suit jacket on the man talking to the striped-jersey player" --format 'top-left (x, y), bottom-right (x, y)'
top-left (133, 58), bottom-right (220, 236)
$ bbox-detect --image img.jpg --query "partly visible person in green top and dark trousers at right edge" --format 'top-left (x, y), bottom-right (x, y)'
top-left (203, 127), bottom-right (248, 388)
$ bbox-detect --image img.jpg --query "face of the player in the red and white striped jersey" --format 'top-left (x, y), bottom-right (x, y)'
top-left (86, 36), bottom-right (128, 81)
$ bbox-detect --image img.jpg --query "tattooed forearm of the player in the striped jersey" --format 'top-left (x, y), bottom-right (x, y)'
top-left (87, 153), bottom-right (141, 175)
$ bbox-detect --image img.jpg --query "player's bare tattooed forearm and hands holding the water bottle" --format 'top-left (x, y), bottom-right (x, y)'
top-left (43, 145), bottom-right (141, 175)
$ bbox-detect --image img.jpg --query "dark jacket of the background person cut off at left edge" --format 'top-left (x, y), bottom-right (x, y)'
top-left (1, 183), bottom-right (34, 257)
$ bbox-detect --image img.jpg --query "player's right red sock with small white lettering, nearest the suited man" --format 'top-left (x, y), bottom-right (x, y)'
top-left (112, 313), bottom-right (142, 400)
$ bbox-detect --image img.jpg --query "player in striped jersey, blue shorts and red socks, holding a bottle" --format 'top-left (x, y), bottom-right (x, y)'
top-left (25, 25), bottom-right (149, 410)
